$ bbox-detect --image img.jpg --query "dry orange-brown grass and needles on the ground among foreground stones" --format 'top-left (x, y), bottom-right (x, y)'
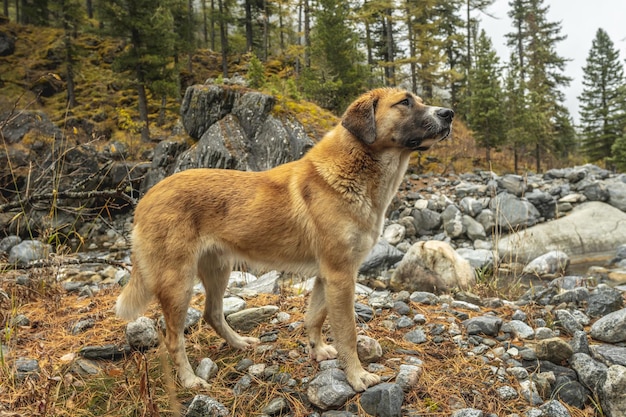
top-left (0, 269), bottom-right (596, 417)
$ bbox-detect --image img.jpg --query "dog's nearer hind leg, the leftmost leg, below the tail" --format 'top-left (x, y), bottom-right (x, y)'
top-left (156, 269), bottom-right (209, 388)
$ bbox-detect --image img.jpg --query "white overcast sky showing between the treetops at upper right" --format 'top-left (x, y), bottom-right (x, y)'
top-left (477, 0), bottom-right (626, 121)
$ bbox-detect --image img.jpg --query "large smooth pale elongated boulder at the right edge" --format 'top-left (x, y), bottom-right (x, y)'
top-left (498, 201), bottom-right (626, 263)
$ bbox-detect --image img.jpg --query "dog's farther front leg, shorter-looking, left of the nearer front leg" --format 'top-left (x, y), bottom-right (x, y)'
top-left (304, 277), bottom-right (337, 361)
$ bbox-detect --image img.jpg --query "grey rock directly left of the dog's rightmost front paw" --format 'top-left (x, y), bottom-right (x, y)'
top-left (307, 368), bottom-right (356, 410)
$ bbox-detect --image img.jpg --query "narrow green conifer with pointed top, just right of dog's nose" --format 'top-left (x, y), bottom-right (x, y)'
top-left (467, 30), bottom-right (505, 163)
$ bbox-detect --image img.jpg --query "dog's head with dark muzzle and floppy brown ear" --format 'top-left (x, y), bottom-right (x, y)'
top-left (341, 88), bottom-right (454, 151)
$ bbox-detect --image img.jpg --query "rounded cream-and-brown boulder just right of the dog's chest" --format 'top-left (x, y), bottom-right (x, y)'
top-left (389, 241), bottom-right (475, 292)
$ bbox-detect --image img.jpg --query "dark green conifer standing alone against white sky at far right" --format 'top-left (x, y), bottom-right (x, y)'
top-left (578, 29), bottom-right (626, 161)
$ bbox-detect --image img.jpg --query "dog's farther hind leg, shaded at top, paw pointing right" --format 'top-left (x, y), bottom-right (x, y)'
top-left (198, 253), bottom-right (259, 349)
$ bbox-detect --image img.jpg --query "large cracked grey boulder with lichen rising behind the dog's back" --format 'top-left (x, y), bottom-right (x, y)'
top-left (174, 85), bottom-right (313, 171)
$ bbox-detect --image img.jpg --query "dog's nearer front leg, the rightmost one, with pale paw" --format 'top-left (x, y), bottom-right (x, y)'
top-left (324, 271), bottom-right (380, 392)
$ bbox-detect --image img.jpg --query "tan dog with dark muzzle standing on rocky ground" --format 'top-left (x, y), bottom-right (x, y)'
top-left (116, 88), bottom-right (454, 392)
